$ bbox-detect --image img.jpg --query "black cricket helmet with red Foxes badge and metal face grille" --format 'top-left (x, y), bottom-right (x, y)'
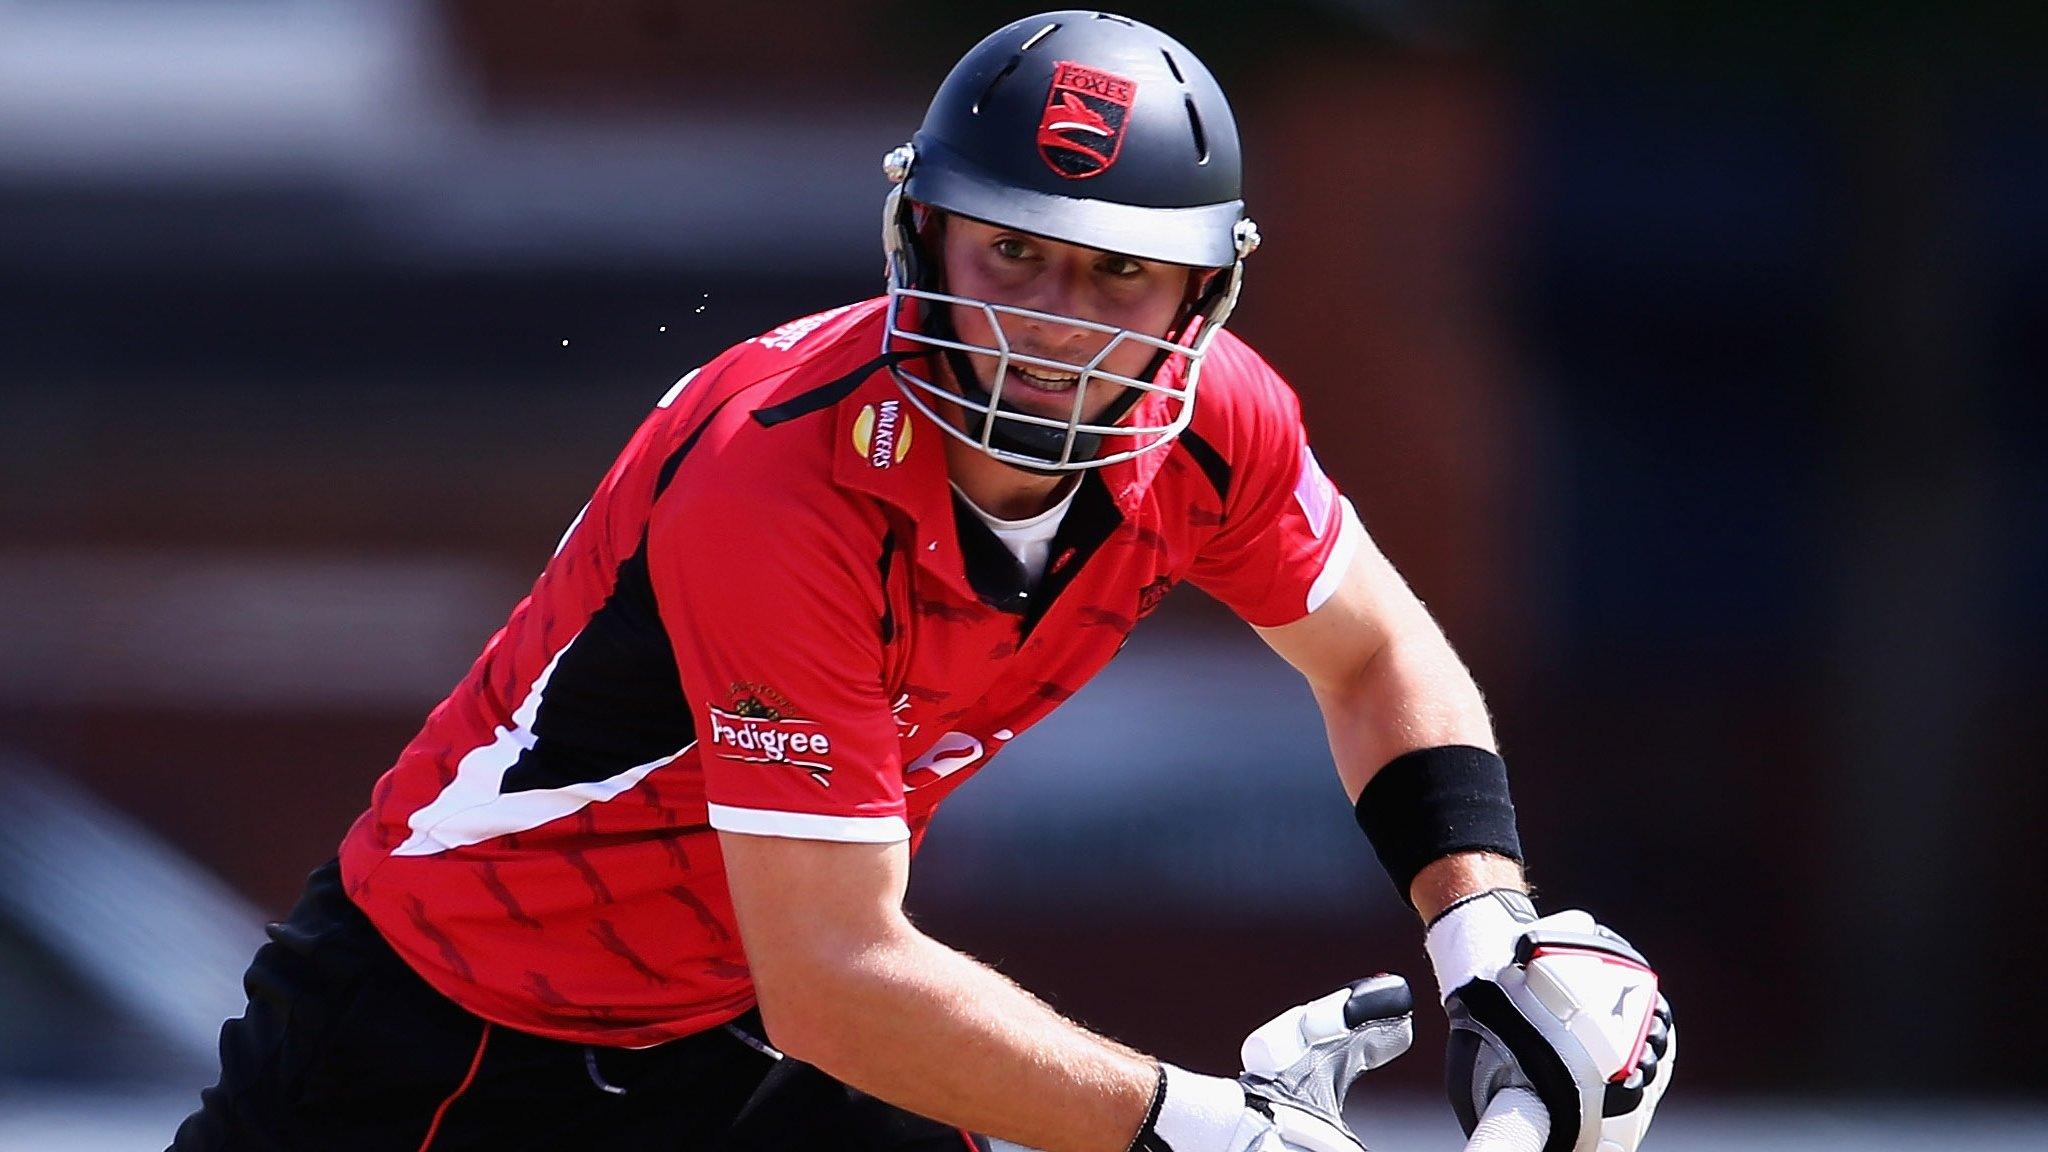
top-left (883, 10), bottom-right (1257, 471)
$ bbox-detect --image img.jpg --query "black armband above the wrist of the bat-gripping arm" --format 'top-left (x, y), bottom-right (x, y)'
top-left (1358, 744), bottom-right (1522, 904)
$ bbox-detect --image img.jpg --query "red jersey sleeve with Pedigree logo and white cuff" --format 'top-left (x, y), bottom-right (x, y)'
top-left (647, 448), bottom-right (909, 845)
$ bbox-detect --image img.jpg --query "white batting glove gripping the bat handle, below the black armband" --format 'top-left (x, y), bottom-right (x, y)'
top-left (1425, 888), bottom-right (1677, 1152)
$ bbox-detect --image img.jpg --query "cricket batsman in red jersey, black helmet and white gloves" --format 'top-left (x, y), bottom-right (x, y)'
top-left (174, 12), bottom-right (1675, 1152)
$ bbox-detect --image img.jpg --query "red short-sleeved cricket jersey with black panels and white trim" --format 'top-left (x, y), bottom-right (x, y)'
top-left (342, 299), bottom-right (1364, 1045)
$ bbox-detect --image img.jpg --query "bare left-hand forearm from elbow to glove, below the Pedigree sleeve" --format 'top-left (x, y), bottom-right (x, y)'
top-left (764, 922), bottom-right (1157, 1152)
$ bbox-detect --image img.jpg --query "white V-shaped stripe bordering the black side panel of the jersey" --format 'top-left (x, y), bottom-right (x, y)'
top-left (391, 633), bottom-right (696, 857)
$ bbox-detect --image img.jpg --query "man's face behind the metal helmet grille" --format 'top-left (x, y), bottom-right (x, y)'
top-left (944, 215), bottom-right (1194, 422)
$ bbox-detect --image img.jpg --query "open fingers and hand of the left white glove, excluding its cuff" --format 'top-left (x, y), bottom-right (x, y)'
top-left (1239, 976), bottom-right (1415, 1129)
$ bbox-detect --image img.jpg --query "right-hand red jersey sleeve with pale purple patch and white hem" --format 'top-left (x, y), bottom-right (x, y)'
top-left (1188, 344), bottom-right (1366, 627)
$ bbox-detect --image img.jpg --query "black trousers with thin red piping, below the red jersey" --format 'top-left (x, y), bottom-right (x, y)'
top-left (172, 861), bottom-right (987, 1152)
